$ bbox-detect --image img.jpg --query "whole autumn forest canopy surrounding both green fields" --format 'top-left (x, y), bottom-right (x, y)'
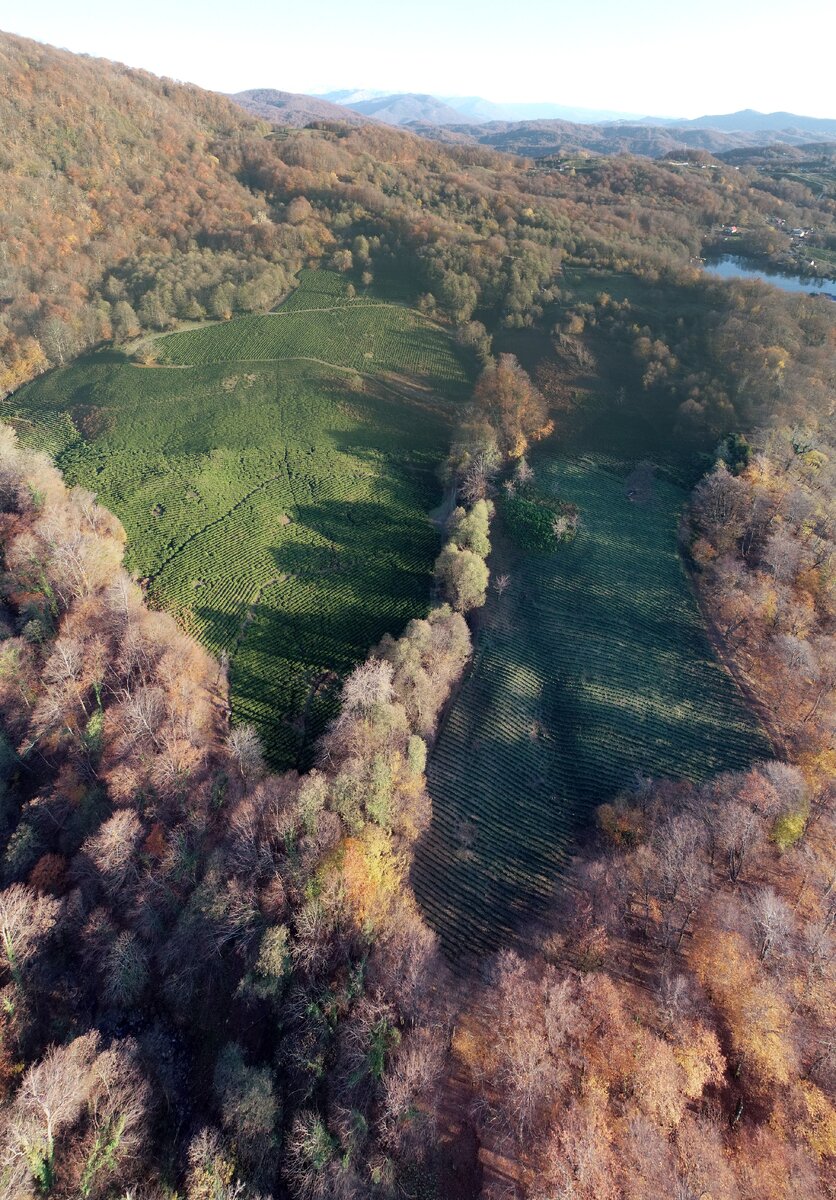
top-left (0, 23), bottom-right (836, 1200)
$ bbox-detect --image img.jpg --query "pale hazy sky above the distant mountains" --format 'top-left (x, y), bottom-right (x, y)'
top-left (6, 0), bottom-right (836, 118)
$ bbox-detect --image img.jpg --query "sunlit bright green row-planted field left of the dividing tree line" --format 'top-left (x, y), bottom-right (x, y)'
top-left (0, 271), bottom-right (467, 767)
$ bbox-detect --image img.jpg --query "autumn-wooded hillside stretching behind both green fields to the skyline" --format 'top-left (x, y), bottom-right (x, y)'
top-left (0, 35), bottom-right (836, 446)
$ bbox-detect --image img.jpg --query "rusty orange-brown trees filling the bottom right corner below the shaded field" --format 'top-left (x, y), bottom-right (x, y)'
top-left (455, 763), bottom-right (836, 1200)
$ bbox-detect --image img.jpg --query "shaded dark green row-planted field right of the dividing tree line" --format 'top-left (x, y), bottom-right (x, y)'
top-left (414, 458), bottom-right (770, 956)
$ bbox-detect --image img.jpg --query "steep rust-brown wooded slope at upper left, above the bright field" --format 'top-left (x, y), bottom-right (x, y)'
top-left (0, 34), bottom-right (269, 395)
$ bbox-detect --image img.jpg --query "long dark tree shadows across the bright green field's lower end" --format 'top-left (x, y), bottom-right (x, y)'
top-left (194, 500), bottom-right (438, 769)
